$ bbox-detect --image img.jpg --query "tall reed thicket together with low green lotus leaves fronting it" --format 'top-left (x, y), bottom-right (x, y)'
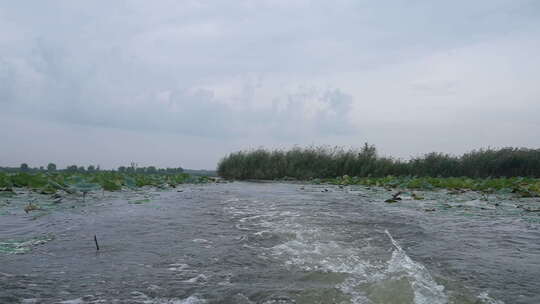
top-left (218, 144), bottom-right (540, 196)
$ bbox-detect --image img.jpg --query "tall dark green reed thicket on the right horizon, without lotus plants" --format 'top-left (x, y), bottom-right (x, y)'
top-left (218, 143), bottom-right (540, 180)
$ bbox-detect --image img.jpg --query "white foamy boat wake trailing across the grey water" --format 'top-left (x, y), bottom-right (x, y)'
top-left (225, 194), bottom-right (510, 304)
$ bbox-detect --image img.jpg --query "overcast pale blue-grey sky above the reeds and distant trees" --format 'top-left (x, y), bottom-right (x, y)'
top-left (0, 0), bottom-right (540, 169)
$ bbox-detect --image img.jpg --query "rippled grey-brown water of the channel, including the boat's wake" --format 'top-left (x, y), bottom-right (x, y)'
top-left (0, 183), bottom-right (540, 304)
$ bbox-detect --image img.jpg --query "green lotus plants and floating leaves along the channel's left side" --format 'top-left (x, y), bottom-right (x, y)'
top-left (0, 163), bottom-right (215, 216)
